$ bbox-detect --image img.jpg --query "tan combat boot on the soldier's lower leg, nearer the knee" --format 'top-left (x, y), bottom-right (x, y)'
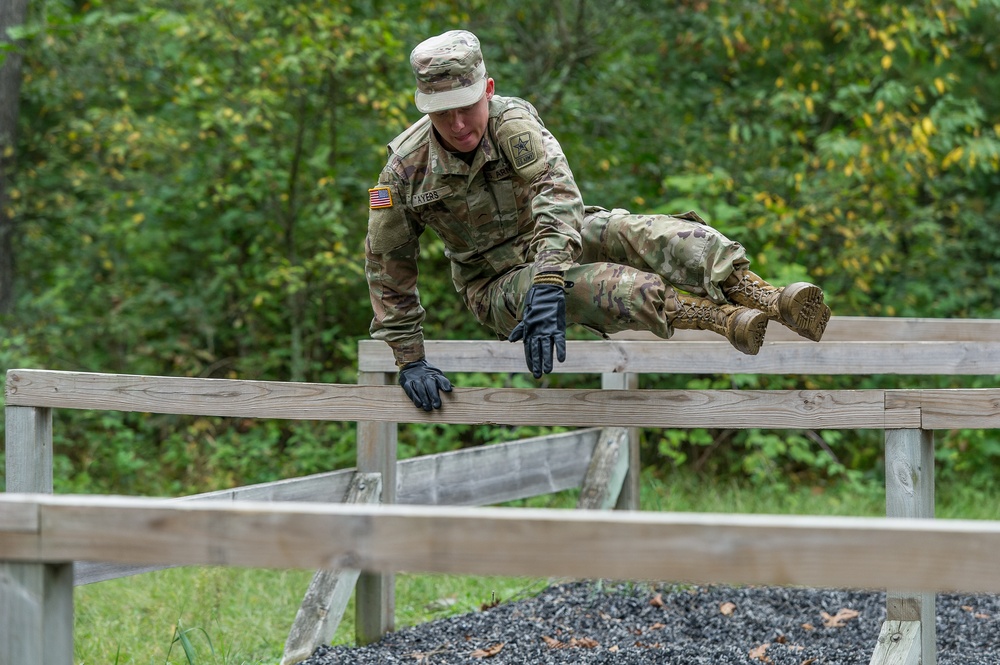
top-left (667, 293), bottom-right (768, 356)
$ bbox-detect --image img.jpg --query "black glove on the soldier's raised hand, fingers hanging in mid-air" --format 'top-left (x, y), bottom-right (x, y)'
top-left (507, 272), bottom-right (573, 379)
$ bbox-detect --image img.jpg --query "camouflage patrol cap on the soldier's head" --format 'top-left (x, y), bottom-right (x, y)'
top-left (410, 30), bottom-right (486, 113)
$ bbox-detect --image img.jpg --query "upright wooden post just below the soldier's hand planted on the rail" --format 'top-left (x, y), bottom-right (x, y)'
top-left (354, 372), bottom-right (396, 644)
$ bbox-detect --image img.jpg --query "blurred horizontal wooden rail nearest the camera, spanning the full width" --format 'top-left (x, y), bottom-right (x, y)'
top-left (0, 494), bottom-right (1000, 593)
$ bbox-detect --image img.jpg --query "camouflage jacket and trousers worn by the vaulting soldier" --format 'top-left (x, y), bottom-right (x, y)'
top-left (365, 96), bottom-right (749, 366)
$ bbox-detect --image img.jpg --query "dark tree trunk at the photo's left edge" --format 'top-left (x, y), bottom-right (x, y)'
top-left (0, 0), bottom-right (28, 314)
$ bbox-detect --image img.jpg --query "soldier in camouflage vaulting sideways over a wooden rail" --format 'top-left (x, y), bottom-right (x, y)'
top-left (365, 30), bottom-right (830, 411)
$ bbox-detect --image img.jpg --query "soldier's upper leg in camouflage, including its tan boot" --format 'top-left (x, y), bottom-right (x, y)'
top-left (581, 210), bottom-right (830, 341)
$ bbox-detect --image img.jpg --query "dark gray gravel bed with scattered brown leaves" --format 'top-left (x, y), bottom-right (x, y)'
top-left (304, 582), bottom-right (1000, 665)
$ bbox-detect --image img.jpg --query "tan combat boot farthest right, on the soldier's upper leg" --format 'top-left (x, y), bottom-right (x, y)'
top-left (722, 270), bottom-right (830, 342)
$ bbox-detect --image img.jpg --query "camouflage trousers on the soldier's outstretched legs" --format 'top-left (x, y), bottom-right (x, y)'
top-left (473, 208), bottom-right (749, 338)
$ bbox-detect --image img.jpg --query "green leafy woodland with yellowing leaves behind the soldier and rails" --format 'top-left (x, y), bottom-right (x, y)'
top-left (0, 0), bottom-right (1000, 494)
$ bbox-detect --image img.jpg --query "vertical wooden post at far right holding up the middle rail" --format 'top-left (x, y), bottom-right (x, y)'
top-left (885, 429), bottom-right (937, 665)
